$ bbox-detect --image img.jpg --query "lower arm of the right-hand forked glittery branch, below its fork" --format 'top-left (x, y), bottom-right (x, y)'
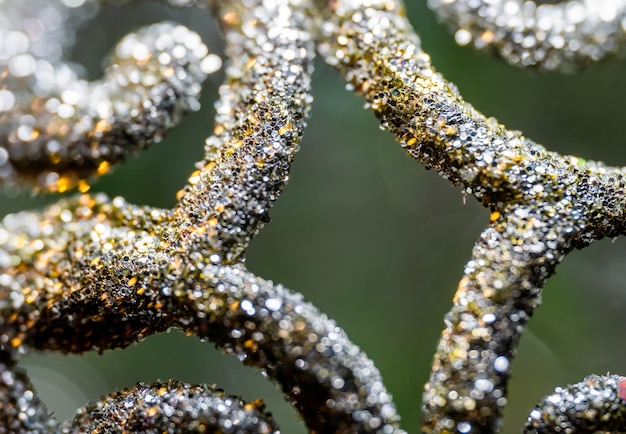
top-left (422, 206), bottom-right (576, 433)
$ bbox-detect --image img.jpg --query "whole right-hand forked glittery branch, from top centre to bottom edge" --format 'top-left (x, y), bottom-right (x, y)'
top-left (320, 0), bottom-right (625, 433)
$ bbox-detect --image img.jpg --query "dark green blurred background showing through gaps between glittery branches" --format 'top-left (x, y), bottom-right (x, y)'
top-left (0, 1), bottom-right (626, 433)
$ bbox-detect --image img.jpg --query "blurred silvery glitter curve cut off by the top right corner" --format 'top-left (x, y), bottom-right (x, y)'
top-left (428, 0), bottom-right (626, 70)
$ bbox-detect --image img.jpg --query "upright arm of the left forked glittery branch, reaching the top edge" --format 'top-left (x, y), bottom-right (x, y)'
top-left (174, 0), bottom-right (314, 263)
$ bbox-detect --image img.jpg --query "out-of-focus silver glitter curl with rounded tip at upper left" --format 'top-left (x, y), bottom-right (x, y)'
top-left (0, 0), bottom-right (220, 192)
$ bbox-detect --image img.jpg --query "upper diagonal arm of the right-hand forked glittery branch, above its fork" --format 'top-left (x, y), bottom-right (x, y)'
top-left (319, 0), bottom-right (623, 214)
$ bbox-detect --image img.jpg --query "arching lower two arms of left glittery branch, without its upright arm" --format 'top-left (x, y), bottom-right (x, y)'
top-left (0, 195), bottom-right (402, 433)
